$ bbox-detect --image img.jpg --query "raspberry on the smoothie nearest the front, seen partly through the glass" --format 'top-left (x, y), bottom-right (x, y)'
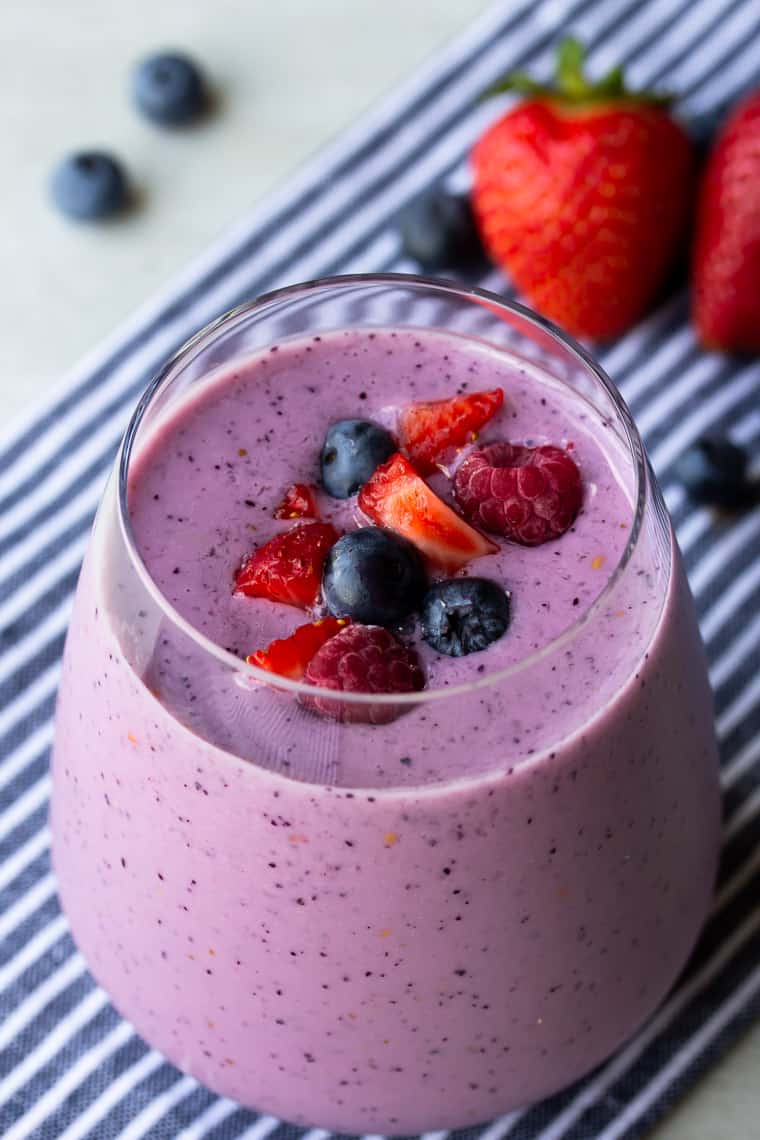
top-left (303, 625), bottom-right (425, 724)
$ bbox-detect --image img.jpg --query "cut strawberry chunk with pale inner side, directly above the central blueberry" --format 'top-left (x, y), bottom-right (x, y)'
top-left (359, 451), bottom-right (499, 571)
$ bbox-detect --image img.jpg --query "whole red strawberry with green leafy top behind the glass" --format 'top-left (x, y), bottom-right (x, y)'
top-left (472, 40), bottom-right (694, 340)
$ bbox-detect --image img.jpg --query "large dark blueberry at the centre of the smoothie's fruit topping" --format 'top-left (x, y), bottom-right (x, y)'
top-left (322, 527), bottom-right (427, 626)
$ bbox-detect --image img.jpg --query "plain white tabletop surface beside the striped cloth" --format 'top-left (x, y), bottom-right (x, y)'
top-left (0, 0), bottom-right (760, 1140)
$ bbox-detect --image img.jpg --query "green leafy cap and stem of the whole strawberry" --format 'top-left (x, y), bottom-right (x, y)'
top-left (484, 35), bottom-right (673, 107)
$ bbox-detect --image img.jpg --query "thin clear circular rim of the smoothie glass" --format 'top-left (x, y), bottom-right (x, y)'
top-left (116, 272), bottom-right (648, 709)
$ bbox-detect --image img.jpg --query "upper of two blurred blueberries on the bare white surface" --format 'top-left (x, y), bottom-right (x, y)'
top-left (132, 51), bottom-right (206, 127)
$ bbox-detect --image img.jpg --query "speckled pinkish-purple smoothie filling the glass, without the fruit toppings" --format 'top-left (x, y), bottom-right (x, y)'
top-left (54, 321), bottom-right (718, 1133)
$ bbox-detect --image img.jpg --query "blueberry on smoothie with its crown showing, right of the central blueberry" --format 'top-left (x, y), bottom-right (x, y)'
top-left (420, 578), bottom-right (509, 657)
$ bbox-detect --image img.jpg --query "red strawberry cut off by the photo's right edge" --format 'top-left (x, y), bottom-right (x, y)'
top-left (693, 91), bottom-right (760, 352)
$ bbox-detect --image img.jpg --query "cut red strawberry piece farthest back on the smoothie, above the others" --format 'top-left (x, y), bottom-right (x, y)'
top-left (399, 388), bottom-right (504, 475)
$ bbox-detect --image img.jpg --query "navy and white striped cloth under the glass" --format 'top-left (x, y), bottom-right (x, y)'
top-left (0, 0), bottom-right (760, 1140)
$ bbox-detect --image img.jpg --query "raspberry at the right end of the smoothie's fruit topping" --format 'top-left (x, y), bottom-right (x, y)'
top-left (453, 443), bottom-right (583, 546)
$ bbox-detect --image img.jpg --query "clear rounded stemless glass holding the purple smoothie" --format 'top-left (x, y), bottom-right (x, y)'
top-left (52, 275), bottom-right (719, 1133)
